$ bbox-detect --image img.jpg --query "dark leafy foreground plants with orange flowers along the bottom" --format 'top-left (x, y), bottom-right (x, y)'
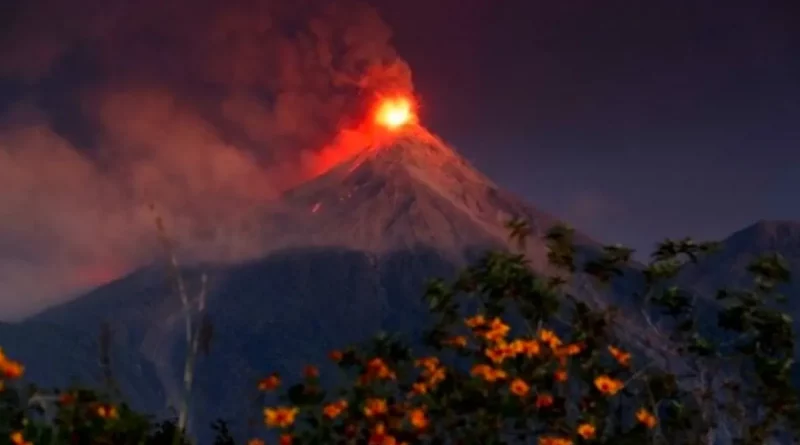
top-left (0, 221), bottom-right (800, 445)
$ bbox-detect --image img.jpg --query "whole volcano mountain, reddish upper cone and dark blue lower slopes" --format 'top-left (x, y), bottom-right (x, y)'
top-left (0, 126), bottom-right (648, 440)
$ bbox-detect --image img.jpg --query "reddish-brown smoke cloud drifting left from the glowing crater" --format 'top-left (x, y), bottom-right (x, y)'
top-left (0, 0), bottom-right (412, 318)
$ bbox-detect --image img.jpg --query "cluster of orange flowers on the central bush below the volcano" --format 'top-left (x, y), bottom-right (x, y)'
top-left (250, 308), bottom-right (658, 445)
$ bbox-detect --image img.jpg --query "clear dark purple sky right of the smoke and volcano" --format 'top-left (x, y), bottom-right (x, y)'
top-left (381, 0), bottom-right (800, 251)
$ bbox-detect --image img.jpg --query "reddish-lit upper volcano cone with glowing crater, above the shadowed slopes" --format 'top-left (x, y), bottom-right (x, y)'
top-left (266, 97), bottom-right (572, 268)
